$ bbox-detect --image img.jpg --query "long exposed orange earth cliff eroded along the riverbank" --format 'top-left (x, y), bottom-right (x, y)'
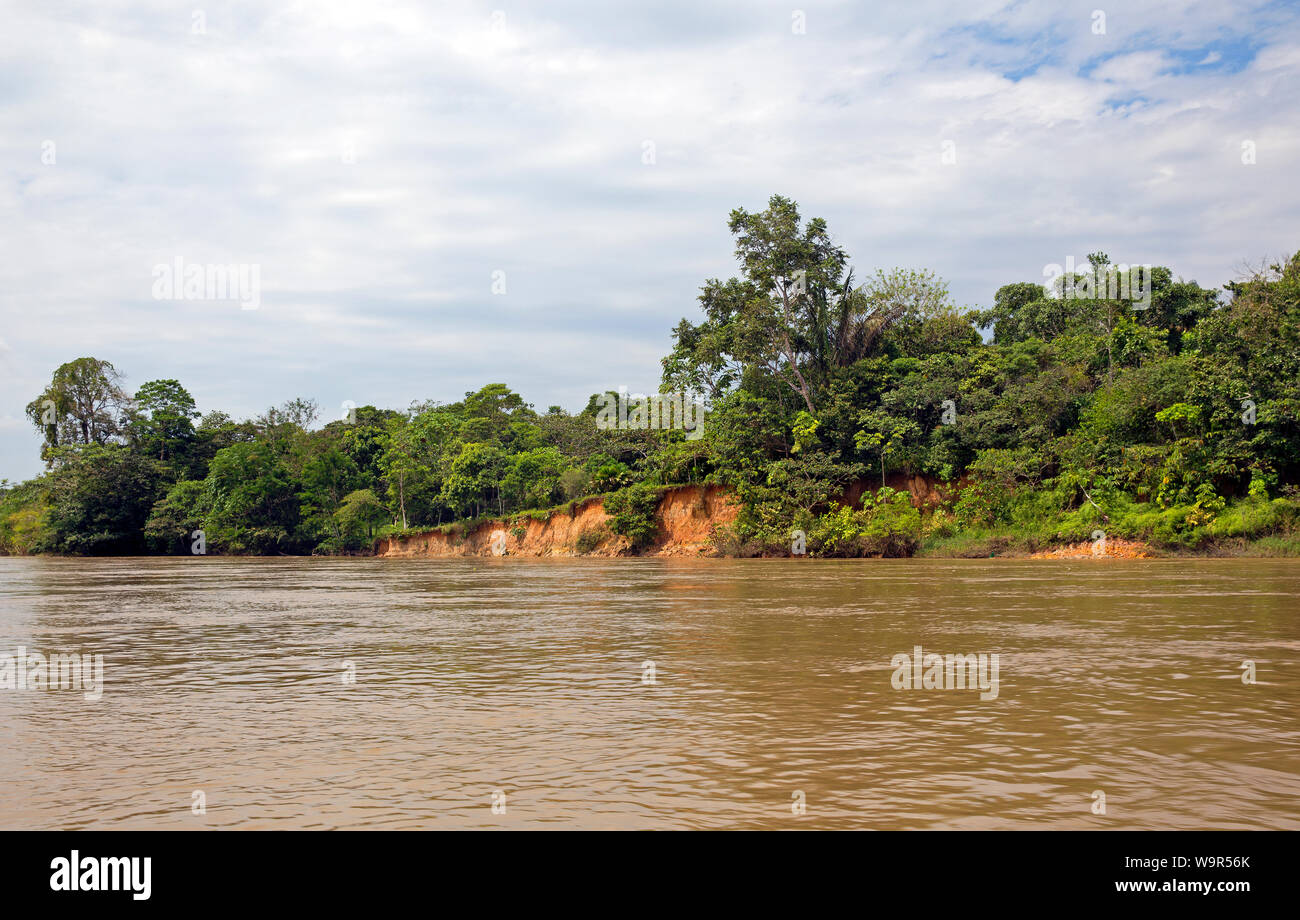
top-left (376, 486), bottom-right (737, 557)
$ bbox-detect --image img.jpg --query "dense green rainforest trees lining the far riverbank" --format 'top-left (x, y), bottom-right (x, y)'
top-left (0, 196), bottom-right (1300, 555)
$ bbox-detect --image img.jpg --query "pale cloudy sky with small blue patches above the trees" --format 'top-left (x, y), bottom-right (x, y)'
top-left (0, 0), bottom-right (1300, 481)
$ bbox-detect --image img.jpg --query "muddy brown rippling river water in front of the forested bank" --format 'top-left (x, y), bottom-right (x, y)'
top-left (0, 557), bottom-right (1300, 828)
